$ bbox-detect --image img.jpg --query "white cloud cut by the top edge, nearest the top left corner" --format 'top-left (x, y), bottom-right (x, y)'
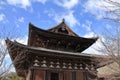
top-left (7, 0), bottom-right (31, 9)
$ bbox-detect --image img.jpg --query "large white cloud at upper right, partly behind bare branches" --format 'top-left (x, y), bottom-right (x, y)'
top-left (84, 0), bottom-right (120, 19)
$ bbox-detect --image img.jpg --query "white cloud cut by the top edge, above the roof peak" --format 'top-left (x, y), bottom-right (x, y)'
top-left (54, 0), bottom-right (79, 9)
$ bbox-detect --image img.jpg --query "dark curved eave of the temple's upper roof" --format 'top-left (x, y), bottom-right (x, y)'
top-left (28, 24), bottom-right (98, 52)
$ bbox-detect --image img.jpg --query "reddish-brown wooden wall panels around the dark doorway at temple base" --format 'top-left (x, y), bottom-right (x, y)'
top-left (26, 70), bottom-right (83, 80)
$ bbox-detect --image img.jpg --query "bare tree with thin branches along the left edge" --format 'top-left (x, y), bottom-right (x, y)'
top-left (0, 27), bottom-right (10, 77)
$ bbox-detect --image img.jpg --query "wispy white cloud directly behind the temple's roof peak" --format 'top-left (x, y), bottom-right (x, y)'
top-left (45, 9), bottom-right (80, 27)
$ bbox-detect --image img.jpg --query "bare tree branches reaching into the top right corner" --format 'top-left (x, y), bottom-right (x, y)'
top-left (101, 0), bottom-right (120, 22)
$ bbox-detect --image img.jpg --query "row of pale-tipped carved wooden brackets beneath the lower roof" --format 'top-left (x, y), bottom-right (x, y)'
top-left (33, 57), bottom-right (96, 71)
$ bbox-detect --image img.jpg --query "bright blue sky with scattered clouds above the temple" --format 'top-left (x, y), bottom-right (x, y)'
top-left (0, 0), bottom-right (119, 53)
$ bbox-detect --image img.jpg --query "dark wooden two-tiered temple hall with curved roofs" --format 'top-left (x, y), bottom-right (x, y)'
top-left (6, 19), bottom-right (107, 80)
